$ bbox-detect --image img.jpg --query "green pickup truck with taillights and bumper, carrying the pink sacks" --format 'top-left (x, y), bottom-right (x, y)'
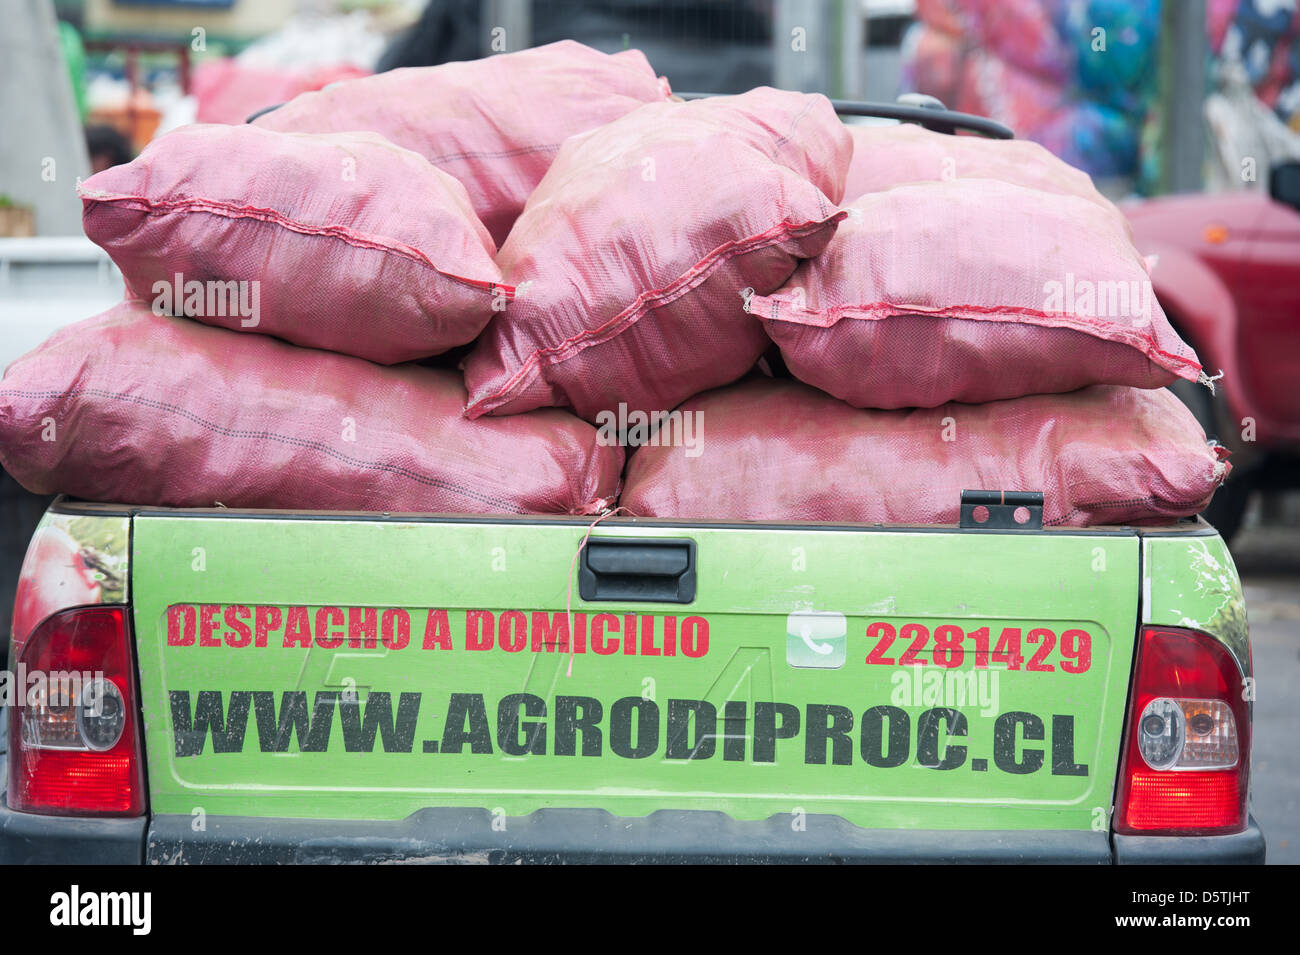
top-left (0, 107), bottom-right (1265, 864)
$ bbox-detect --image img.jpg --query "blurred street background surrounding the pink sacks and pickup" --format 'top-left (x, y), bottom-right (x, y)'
top-left (0, 0), bottom-right (1300, 861)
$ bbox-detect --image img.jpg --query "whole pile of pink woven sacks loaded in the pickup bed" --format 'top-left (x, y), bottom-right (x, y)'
top-left (0, 43), bottom-right (1227, 525)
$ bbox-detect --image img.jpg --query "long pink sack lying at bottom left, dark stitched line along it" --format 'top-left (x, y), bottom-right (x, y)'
top-left (0, 303), bottom-right (623, 513)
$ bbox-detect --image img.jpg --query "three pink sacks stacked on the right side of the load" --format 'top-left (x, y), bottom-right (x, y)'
top-left (620, 126), bottom-right (1230, 526)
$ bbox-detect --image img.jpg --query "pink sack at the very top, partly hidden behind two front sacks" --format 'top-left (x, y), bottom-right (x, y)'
top-left (256, 40), bottom-right (671, 246)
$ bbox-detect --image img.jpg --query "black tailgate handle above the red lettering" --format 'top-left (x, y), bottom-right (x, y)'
top-left (577, 538), bottom-right (696, 603)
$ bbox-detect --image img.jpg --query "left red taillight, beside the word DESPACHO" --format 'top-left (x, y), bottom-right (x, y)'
top-left (8, 607), bottom-right (144, 816)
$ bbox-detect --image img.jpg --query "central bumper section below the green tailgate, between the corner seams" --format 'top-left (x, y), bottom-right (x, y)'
top-left (146, 808), bottom-right (1110, 864)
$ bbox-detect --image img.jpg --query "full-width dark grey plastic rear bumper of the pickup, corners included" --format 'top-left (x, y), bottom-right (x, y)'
top-left (0, 806), bottom-right (1264, 865)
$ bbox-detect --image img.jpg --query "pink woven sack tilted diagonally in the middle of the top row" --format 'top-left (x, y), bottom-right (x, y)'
top-left (465, 88), bottom-right (852, 421)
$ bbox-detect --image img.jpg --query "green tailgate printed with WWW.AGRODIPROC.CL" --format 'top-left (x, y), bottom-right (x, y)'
top-left (133, 512), bottom-right (1140, 829)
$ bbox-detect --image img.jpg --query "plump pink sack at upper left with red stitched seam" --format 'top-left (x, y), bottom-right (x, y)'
top-left (79, 125), bottom-right (510, 364)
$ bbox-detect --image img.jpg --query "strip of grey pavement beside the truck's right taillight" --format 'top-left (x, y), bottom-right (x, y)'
top-left (1231, 522), bottom-right (1300, 865)
